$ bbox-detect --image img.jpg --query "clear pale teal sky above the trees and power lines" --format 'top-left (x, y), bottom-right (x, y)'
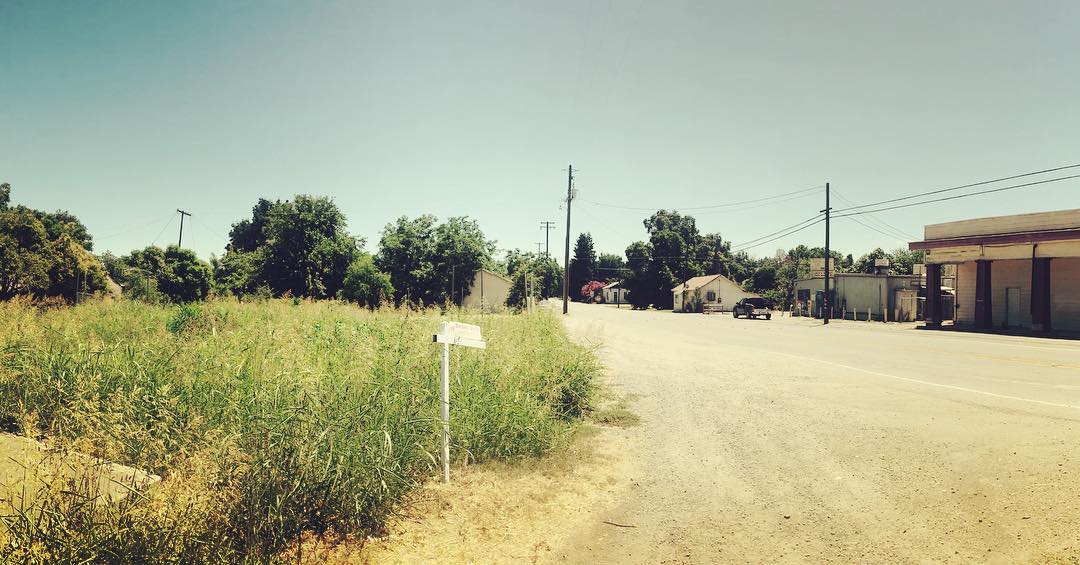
top-left (0, 0), bottom-right (1080, 263)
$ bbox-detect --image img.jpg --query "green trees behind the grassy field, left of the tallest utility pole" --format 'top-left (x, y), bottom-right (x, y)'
top-left (0, 184), bottom-right (563, 308)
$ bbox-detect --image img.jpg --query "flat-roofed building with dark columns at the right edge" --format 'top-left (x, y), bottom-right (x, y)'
top-left (908, 210), bottom-right (1080, 332)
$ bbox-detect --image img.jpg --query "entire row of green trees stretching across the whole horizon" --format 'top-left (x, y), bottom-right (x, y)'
top-left (0, 184), bottom-right (922, 309)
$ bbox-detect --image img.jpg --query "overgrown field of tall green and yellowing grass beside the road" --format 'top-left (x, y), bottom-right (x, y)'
top-left (0, 300), bottom-right (597, 562)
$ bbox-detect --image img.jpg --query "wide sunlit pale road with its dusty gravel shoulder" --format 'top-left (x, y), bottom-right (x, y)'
top-left (558, 305), bottom-right (1080, 563)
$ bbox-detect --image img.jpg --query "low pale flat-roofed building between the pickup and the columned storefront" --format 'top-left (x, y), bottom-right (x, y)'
top-left (795, 272), bottom-right (922, 322)
